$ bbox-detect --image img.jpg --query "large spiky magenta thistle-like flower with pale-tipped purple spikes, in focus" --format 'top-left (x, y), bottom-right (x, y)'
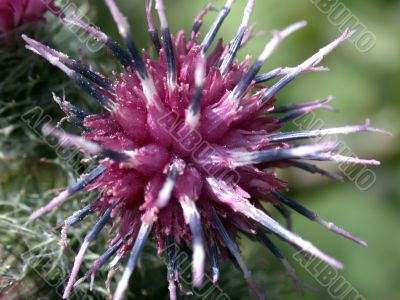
top-left (23, 0), bottom-right (390, 299)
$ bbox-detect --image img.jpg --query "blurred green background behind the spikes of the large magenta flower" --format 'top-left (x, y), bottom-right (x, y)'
top-left (0, 0), bottom-right (400, 300)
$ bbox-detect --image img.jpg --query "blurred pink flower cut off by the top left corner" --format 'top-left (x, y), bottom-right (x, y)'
top-left (0, 0), bottom-right (56, 33)
